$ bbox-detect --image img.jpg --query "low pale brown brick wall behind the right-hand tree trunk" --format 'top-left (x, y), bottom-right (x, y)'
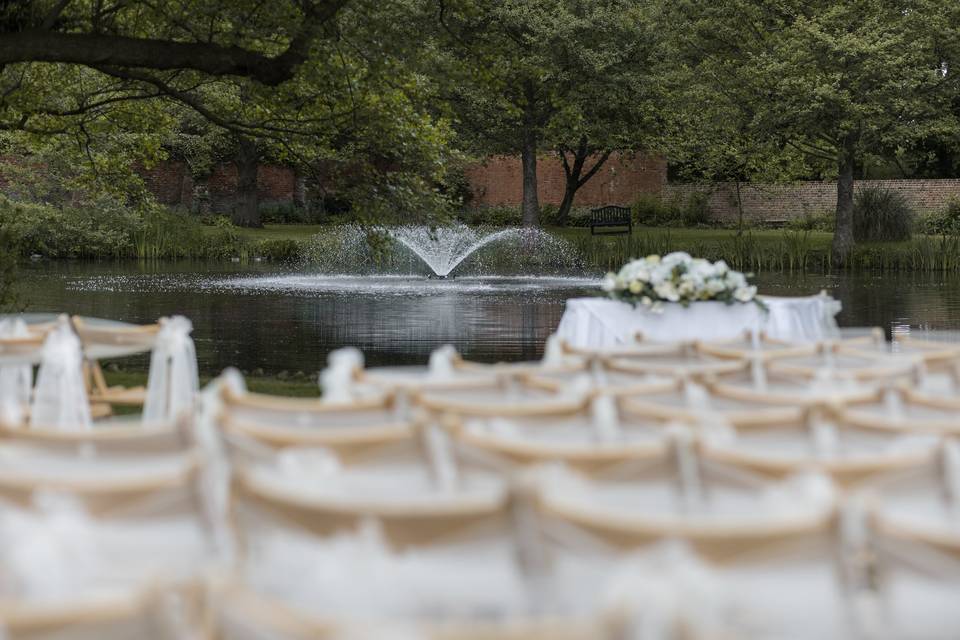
top-left (662, 179), bottom-right (960, 220)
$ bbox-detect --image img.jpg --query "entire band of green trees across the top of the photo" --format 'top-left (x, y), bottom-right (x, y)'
top-left (0, 0), bottom-right (960, 264)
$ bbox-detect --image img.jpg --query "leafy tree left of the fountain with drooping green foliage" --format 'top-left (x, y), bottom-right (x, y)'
top-left (0, 0), bottom-right (458, 226)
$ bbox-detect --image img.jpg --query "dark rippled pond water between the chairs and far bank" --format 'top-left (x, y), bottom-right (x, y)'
top-left (13, 261), bottom-right (960, 374)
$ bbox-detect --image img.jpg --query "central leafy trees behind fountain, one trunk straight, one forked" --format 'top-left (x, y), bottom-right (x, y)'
top-left (415, 0), bottom-right (648, 226)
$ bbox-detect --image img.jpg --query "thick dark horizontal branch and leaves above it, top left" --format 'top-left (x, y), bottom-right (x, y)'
top-left (0, 0), bottom-right (347, 85)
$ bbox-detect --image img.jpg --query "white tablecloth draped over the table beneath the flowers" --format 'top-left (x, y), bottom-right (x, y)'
top-left (557, 294), bottom-right (840, 348)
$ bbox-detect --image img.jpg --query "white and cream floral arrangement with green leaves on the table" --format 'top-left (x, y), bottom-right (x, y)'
top-left (601, 251), bottom-right (763, 311)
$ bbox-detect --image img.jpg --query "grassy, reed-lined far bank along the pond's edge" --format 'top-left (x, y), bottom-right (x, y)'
top-left (13, 214), bottom-right (960, 274)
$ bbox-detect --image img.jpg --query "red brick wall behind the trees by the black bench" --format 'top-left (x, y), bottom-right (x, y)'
top-left (466, 154), bottom-right (667, 207)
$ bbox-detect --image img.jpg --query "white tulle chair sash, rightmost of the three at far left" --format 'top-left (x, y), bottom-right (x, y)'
top-left (143, 316), bottom-right (200, 423)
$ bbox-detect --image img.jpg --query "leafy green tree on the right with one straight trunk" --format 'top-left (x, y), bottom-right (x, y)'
top-left (662, 0), bottom-right (956, 265)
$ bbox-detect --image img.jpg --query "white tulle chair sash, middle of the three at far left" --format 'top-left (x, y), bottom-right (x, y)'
top-left (30, 316), bottom-right (93, 430)
